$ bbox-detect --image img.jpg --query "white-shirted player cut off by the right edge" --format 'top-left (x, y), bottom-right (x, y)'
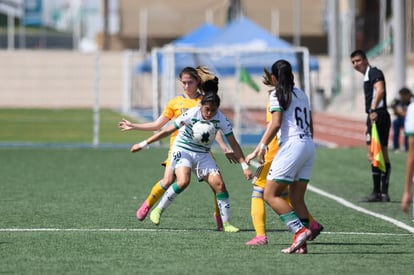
top-left (401, 99), bottom-right (414, 214)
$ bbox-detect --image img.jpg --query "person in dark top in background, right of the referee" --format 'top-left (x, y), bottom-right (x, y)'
top-left (391, 87), bottom-right (413, 151)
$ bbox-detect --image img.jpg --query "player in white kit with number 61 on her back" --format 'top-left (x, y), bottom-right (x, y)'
top-left (247, 60), bottom-right (315, 254)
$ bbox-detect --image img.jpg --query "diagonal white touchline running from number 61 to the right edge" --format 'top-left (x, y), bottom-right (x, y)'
top-left (308, 184), bottom-right (414, 233)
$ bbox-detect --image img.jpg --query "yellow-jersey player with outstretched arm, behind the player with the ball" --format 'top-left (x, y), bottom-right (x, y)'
top-left (119, 67), bottom-right (237, 230)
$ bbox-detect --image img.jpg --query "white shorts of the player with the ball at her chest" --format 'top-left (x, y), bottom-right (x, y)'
top-left (171, 150), bottom-right (220, 181)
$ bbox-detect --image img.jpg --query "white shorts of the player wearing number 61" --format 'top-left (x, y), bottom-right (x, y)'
top-left (267, 139), bottom-right (315, 183)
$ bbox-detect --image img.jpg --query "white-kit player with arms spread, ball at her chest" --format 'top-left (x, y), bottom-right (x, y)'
top-left (131, 82), bottom-right (253, 232)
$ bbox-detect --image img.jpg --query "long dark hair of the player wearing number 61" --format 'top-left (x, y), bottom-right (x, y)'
top-left (272, 59), bottom-right (295, 110)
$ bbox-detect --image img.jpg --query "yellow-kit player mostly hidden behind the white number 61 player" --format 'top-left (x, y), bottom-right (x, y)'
top-left (246, 70), bottom-right (323, 245)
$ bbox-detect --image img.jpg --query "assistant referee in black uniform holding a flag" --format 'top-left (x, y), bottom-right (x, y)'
top-left (351, 50), bottom-right (391, 202)
